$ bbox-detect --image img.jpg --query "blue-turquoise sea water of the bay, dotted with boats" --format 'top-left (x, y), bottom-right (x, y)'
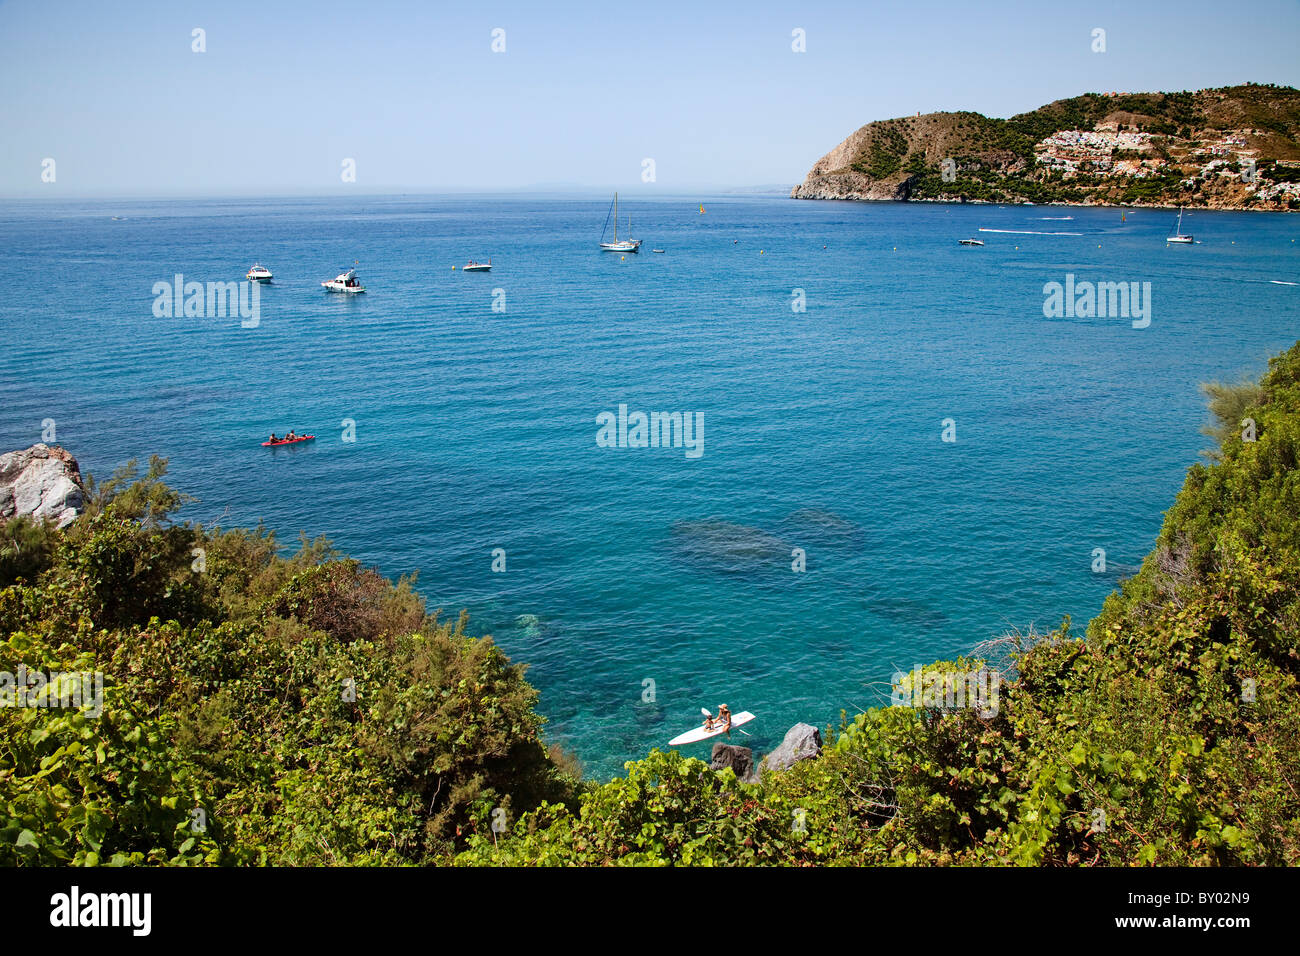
top-left (0, 198), bottom-right (1300, 777)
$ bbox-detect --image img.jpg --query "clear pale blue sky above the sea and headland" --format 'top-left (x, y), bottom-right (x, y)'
top-left (0, 0), bottom-right (1300, 196)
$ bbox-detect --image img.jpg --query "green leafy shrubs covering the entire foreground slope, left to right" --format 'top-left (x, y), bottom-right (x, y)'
top-left (0, 343), bottom-right (1300, 866)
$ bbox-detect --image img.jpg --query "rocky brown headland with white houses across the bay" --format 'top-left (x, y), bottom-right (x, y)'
top-left (790, 83), bottom-right (1300, 209)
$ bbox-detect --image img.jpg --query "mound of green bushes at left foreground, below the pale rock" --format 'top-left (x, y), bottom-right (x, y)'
top-left (0, 473), bottom-right (576, 865)
